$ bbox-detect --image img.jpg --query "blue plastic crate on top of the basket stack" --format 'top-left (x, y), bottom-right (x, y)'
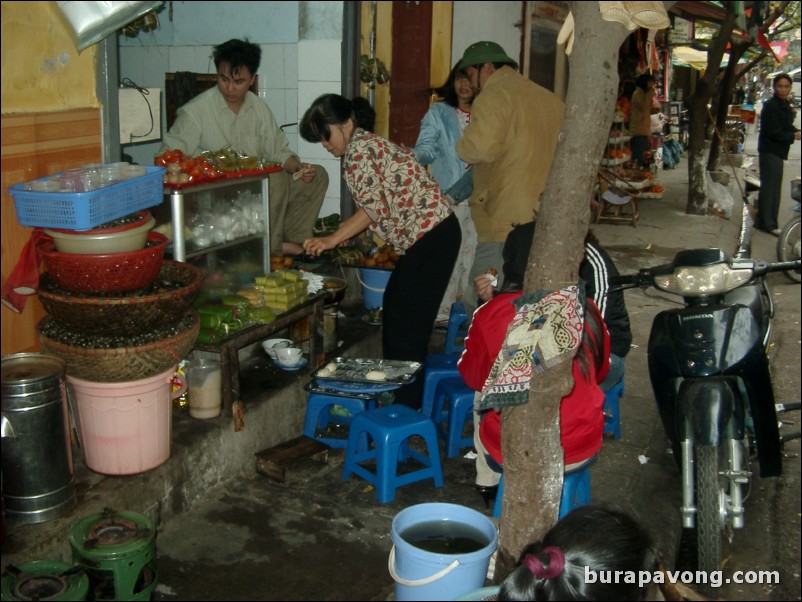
top-left (8, 166), bottom-right (165, 230)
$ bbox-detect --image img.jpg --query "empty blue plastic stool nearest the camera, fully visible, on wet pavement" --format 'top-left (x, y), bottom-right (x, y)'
top-left (343, 405), bottom-right (443, 504)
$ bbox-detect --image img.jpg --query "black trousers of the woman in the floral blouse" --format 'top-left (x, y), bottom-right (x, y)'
top-left (382, 214), bottom-right (462, 409)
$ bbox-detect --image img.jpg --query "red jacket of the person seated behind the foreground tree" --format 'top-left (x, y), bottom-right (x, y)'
top-left (458, 293), bottom-right (610, 465)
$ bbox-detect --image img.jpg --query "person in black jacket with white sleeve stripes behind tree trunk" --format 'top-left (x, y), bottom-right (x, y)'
top-left (475, 221), bottom-right (632, 391)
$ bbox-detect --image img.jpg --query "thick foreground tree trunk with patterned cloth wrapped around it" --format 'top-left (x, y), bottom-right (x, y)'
top-left (496, 2), bottom-right (628, 581)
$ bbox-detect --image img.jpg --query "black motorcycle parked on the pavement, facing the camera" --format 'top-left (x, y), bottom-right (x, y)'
top-left (611, 195), bottom-right (802, 574)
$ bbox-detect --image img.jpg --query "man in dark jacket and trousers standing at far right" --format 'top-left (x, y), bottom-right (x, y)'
top-left (755, 73), bottom-right (799, 236)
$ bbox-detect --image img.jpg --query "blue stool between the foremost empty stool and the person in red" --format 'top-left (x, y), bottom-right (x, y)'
top-left (432, 376), bottom-right (475, 458)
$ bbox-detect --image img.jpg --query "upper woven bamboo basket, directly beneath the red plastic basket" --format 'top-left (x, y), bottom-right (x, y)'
top-left (37, 260), bottom-right (203, 336)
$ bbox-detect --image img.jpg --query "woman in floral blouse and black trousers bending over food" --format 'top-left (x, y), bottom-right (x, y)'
top-left (300, 94), bottom-right (461, 408)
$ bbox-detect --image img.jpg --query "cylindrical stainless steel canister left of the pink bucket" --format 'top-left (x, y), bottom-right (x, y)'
top-left (2, 353), bottom-right (75, 524)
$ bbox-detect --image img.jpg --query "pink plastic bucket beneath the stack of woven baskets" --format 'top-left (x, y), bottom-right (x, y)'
top-left (67, 368), bottom-right (175, 475)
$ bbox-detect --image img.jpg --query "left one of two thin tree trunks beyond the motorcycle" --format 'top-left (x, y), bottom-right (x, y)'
top-left (685, 2), bottom-right (735, 215)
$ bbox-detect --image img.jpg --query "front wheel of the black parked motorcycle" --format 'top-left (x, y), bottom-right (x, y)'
top-left (696, 446), bottom-right (722, 575)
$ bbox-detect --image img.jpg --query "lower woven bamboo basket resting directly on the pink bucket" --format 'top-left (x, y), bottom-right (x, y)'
top-left (37, 310), bottom-right (200, 383)
